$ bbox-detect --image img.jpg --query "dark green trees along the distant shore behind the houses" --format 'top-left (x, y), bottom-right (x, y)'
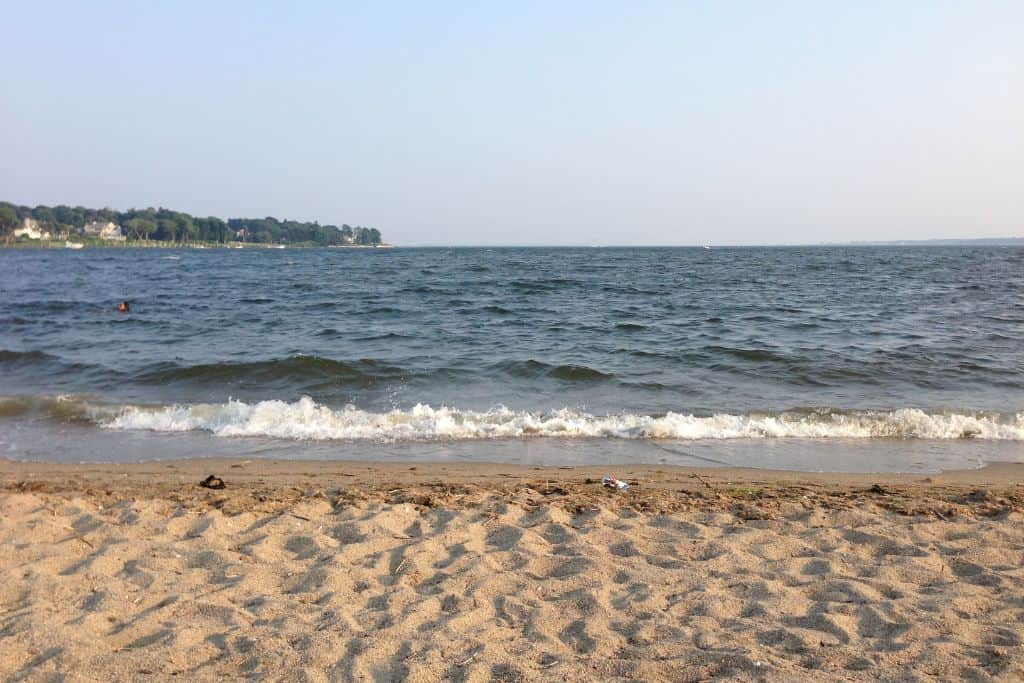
top-left (0, 202), bottom-right (381, 246)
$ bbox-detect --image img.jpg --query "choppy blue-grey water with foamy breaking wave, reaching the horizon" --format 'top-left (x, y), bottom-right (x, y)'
top-left (0, 247), bottom-right (1024, 472)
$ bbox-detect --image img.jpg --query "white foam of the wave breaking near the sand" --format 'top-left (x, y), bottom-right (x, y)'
top-left (101, 397), bottom-right (1024, 441)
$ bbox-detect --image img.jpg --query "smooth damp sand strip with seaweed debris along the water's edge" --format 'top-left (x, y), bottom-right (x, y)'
top-left (0, 458), bottom-right (1024, 518)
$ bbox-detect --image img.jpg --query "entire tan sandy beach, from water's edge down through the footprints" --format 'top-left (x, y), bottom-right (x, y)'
top-left (0, 461), bottom-right (1024, 681)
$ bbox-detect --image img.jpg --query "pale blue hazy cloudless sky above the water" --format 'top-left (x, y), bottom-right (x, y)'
top-left (0, 0), bottom-right (1024, 245)
